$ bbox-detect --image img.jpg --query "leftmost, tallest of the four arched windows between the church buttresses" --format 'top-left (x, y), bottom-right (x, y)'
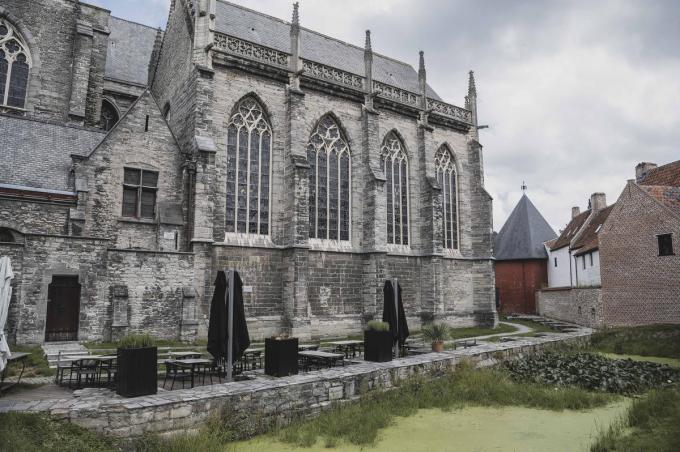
top-left (225, 97), bottom-right (272, 235)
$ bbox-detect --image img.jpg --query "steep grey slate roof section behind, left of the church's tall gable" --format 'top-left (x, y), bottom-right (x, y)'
top-left (104, 16), bottom-right (157, 85)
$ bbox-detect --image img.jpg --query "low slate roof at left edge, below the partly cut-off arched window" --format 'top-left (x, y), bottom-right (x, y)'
top-left (0, 115), bottom-right (105, 191)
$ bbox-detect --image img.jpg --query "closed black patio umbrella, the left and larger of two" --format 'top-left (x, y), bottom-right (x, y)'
top-left (208, 270), bottom-right (250, 361)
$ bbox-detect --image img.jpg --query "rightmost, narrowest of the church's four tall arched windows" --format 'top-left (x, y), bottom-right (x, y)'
top-left (434, 146), bottom-right (458, 249)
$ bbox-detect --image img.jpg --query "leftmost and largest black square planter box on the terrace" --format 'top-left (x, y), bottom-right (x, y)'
top-left (116, 347), bottom-right (158, 397)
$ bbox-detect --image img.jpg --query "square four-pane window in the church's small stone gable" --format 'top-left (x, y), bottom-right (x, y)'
top-left (123, 168), bottom-right (158, 218)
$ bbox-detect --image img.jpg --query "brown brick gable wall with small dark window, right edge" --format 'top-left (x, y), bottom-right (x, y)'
top-left (599, 181), bottom-right (680, 326)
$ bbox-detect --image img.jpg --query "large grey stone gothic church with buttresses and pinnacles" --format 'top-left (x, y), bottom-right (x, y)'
top-left (0, 0), bottom-right (497, 343)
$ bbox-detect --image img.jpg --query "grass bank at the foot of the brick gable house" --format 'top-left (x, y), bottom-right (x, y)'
top-left (591, 325), bottom-right (680, 359)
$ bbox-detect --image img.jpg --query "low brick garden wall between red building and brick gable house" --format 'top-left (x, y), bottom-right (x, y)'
top-left (536, 288), bottom-right (604, 328)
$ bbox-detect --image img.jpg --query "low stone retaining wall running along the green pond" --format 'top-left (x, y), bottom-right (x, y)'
top-left (0, 327), bottom-right (593, 437)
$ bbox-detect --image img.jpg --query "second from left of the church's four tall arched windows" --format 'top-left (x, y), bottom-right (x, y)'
top-left (307, 116), bottom-right (352, 244)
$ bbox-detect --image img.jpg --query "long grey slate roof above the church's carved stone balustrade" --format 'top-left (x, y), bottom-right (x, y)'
top-left (215, 0), bottom-right (441, 100)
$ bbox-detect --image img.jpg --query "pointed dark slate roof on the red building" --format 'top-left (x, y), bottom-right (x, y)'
top-left (494, 195), bottom-right (557, 260)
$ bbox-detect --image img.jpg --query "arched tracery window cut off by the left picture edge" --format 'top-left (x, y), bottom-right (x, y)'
top-left (0, 18), bottom-right (31, 108)
